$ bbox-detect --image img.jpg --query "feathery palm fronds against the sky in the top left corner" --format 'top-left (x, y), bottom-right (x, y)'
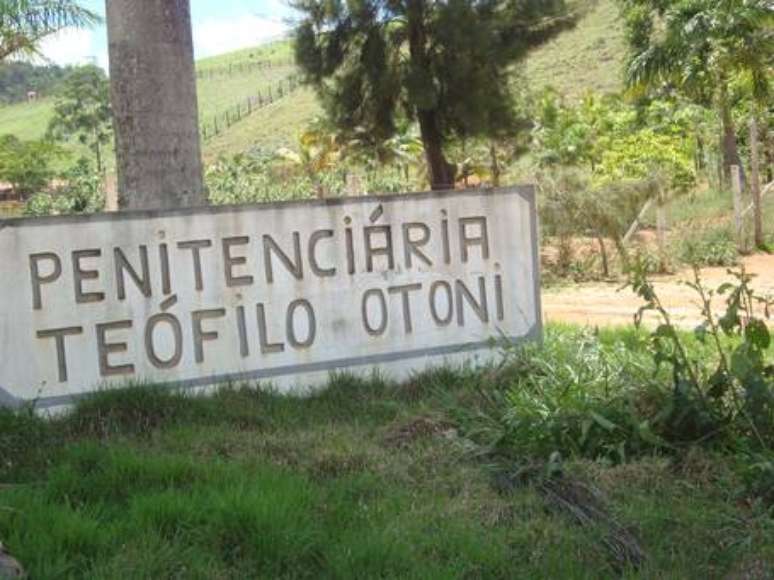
top-left (0, 0), bottom-right (99, 61)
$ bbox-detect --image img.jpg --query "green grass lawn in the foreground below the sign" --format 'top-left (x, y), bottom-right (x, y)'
top-left (0, 330), bottom-right (774, 579)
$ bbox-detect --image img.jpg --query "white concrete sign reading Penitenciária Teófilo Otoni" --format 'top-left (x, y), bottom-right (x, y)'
top-left (0, 188), bottom-right (541, 408)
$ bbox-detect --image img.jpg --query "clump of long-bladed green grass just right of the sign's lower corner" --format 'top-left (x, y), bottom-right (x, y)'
top-left (450, 328), bottom-right (667, 462)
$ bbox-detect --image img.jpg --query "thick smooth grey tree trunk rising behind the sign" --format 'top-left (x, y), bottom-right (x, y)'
top-left (105, 0), bottom-right (205, 209)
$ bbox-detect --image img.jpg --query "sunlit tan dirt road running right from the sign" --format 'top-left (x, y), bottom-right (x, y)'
top-left (543, 254), bottom-right (774, 328)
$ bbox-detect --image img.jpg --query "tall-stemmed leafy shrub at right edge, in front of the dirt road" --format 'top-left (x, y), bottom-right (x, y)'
top-left (631, 267), bottom-right (774, 450)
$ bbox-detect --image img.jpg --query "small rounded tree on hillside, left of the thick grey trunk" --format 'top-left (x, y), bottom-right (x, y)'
top-left (48, 66), bottom-right (113, 173)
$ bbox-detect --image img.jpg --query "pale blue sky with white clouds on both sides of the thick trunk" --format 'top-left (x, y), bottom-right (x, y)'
top-left (37, 0), bottom-right (292, 69)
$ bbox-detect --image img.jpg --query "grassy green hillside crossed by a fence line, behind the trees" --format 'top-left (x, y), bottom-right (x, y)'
top-left (0, 0), bottom-right (625, 161)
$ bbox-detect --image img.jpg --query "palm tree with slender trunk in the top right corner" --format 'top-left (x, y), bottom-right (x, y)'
top-left (621, 0), bottom-right (774, 186)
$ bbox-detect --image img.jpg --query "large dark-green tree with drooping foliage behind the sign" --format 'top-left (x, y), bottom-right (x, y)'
top-left (292, 0), bottom-right (573, 190)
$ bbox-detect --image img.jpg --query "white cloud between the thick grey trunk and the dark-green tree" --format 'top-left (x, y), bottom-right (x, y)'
top-left (193, 15), bottom-right (287, 58)
